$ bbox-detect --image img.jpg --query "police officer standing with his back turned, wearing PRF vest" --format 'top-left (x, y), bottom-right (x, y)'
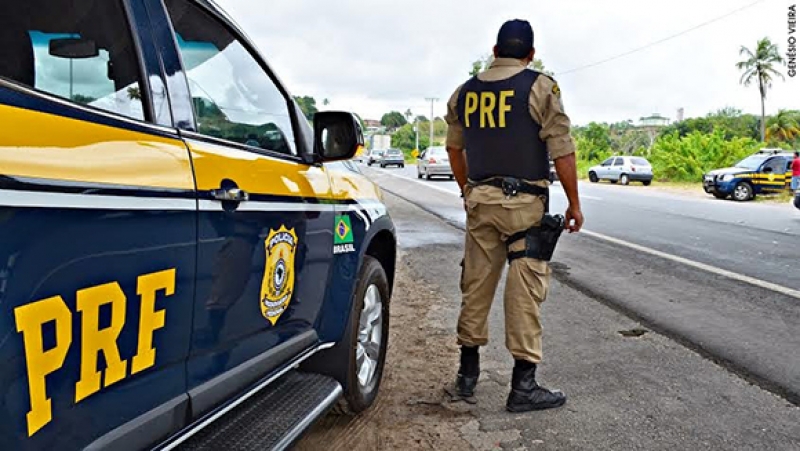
top-left (446, 20), bottom-right (583, 412)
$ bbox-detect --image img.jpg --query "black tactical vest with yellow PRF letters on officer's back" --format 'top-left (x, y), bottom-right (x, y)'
top-left (457, 69), bottom-right (550, 180)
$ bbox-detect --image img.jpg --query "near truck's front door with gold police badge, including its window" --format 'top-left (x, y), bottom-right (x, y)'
top-left (155, 0), bottom-right (334, 417)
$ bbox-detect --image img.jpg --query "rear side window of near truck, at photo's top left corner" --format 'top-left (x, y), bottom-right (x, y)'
top-left (0, 0), bottom-right (144, 120)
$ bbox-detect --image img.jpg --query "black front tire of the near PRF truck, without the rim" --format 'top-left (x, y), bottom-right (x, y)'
top-left (300, 255), bottom-right (390, 415)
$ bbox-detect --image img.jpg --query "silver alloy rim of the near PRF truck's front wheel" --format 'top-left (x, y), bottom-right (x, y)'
top-left (356, 284), bottom-right (383, 388)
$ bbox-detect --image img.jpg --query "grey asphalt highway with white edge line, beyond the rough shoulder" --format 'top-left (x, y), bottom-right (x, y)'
top-left (364, 166), bottom-right (800, 404)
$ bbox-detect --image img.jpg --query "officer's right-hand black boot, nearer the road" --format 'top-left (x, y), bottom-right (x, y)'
top-left (506, 360), bottom-right (567, 412)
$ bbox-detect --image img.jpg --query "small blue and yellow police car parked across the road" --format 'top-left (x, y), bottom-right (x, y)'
top-left (703, 149), bottom-right (792, 201)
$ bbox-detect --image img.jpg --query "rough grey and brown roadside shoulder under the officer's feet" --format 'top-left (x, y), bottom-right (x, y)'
top-left (296, 192), bottom-right (800, 451)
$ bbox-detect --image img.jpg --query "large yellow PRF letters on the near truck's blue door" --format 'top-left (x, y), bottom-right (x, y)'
top-left (14, 268), bottom-right (176, 436)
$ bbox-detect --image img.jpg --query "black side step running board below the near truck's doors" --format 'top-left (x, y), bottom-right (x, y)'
top-left (177, 371), bottom-right (342, 451)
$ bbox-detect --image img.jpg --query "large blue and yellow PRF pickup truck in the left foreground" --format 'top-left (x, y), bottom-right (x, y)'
top-left (0, 0), bottom-right (396, 450)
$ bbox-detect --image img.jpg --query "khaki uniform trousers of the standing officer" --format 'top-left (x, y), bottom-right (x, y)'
top-left (458, 182), bottom-right (550, 363)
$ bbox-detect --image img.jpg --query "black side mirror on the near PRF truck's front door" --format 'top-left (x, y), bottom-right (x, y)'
top-left (314, 111), bottom-right (364, 161)
